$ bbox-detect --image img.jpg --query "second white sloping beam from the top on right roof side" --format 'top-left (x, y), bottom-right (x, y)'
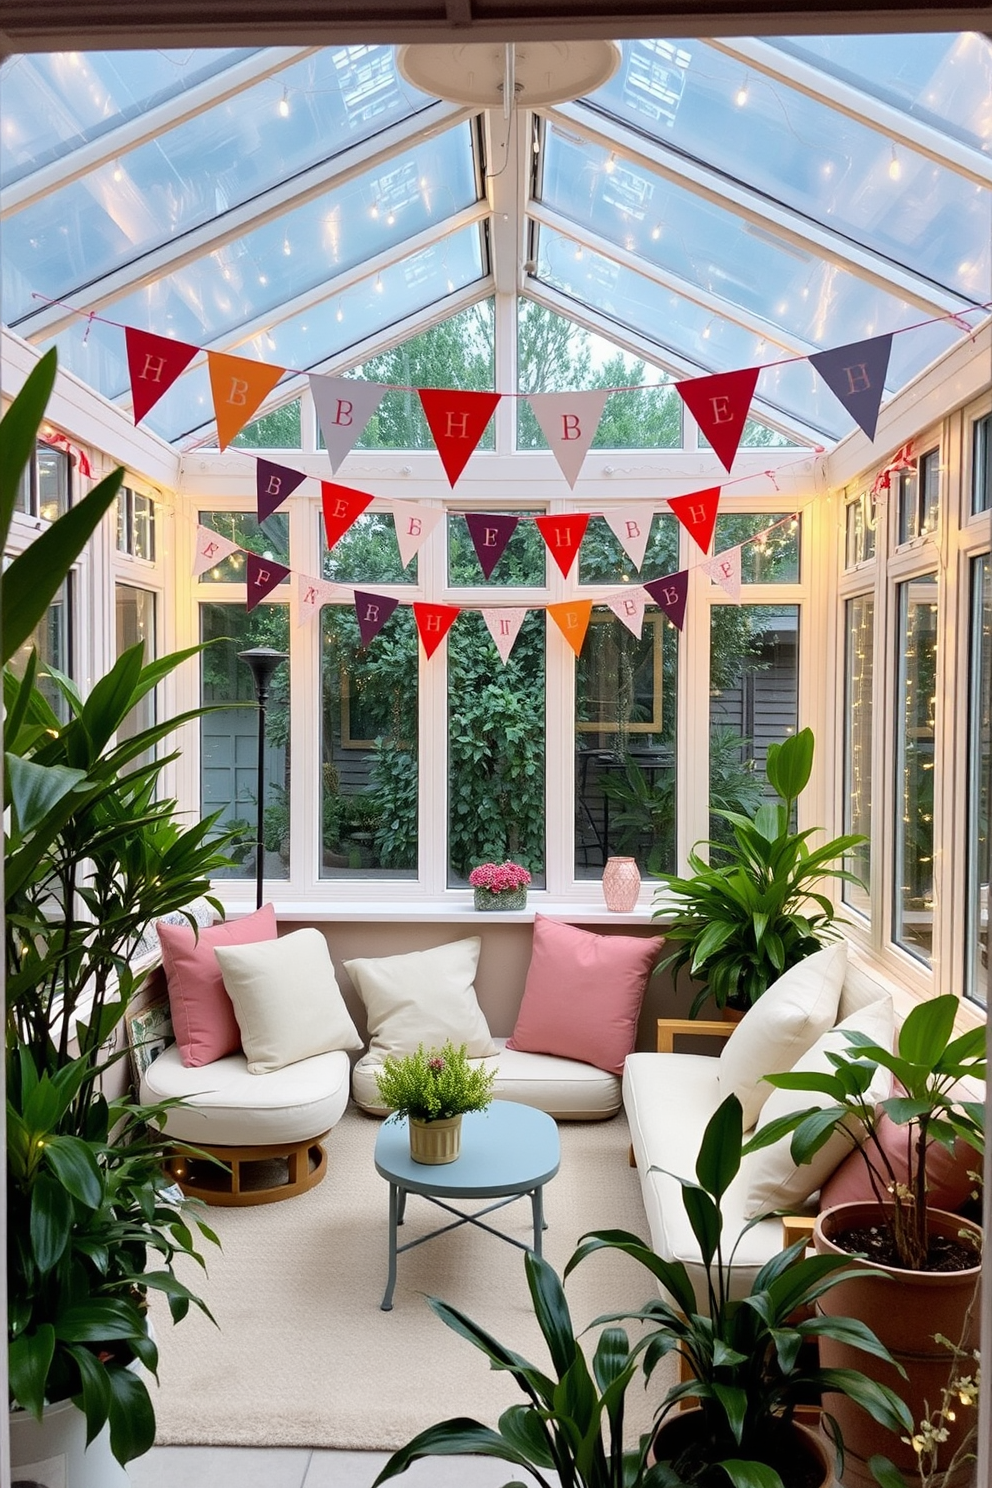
top-left (541, 103), bottom-right (974, 315)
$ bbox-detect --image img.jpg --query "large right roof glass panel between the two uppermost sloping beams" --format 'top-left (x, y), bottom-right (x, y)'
top-left (592, 39), bottom-right (992, 302)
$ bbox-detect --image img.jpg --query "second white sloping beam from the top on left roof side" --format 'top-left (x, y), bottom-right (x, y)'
top-left (12, 103), bottom-right (473, 342)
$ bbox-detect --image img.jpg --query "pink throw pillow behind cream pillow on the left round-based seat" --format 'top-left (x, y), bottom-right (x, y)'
top-left (156, 905), bottom-right (278, 1065)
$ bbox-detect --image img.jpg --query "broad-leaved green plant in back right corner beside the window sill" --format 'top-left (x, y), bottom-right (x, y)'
top-left (654, 729), bottom-right (866, 1018)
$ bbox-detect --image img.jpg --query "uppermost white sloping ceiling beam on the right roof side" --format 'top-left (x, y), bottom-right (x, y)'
top-left (706, 39), bottom-right (992, 187)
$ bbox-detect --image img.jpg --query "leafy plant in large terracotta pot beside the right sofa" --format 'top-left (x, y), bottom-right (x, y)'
top-left (748, 995), bottom-right (986, 1484)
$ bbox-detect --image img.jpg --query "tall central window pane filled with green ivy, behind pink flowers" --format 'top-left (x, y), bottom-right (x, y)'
top-left (448, 610), bottom-right (544, 888)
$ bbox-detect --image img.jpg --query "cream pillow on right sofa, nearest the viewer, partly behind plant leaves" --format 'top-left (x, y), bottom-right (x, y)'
top-left (744, 997), bottom-right (895, 1219)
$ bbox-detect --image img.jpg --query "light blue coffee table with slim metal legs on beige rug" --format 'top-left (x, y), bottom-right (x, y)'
top-left (375, 1101), bottom-right (561, 1312)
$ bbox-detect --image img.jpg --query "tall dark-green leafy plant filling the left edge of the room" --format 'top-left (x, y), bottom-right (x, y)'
top-left (0, 354), bottom-right (236, 1488)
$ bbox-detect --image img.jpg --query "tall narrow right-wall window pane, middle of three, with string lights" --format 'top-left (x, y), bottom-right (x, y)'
top-left (892, 573), bottom-right (937, 964)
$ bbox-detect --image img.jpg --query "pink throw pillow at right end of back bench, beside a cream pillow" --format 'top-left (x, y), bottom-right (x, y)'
top-left (507, 915), bottom-right (665, 1074)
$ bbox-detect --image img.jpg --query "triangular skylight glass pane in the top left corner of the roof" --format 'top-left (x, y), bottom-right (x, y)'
top-left (0, 48), bottom-right (260, 186)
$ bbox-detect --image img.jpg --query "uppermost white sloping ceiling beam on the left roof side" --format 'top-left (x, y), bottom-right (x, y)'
top-left (0, 46), bottom-right (320, 220)
